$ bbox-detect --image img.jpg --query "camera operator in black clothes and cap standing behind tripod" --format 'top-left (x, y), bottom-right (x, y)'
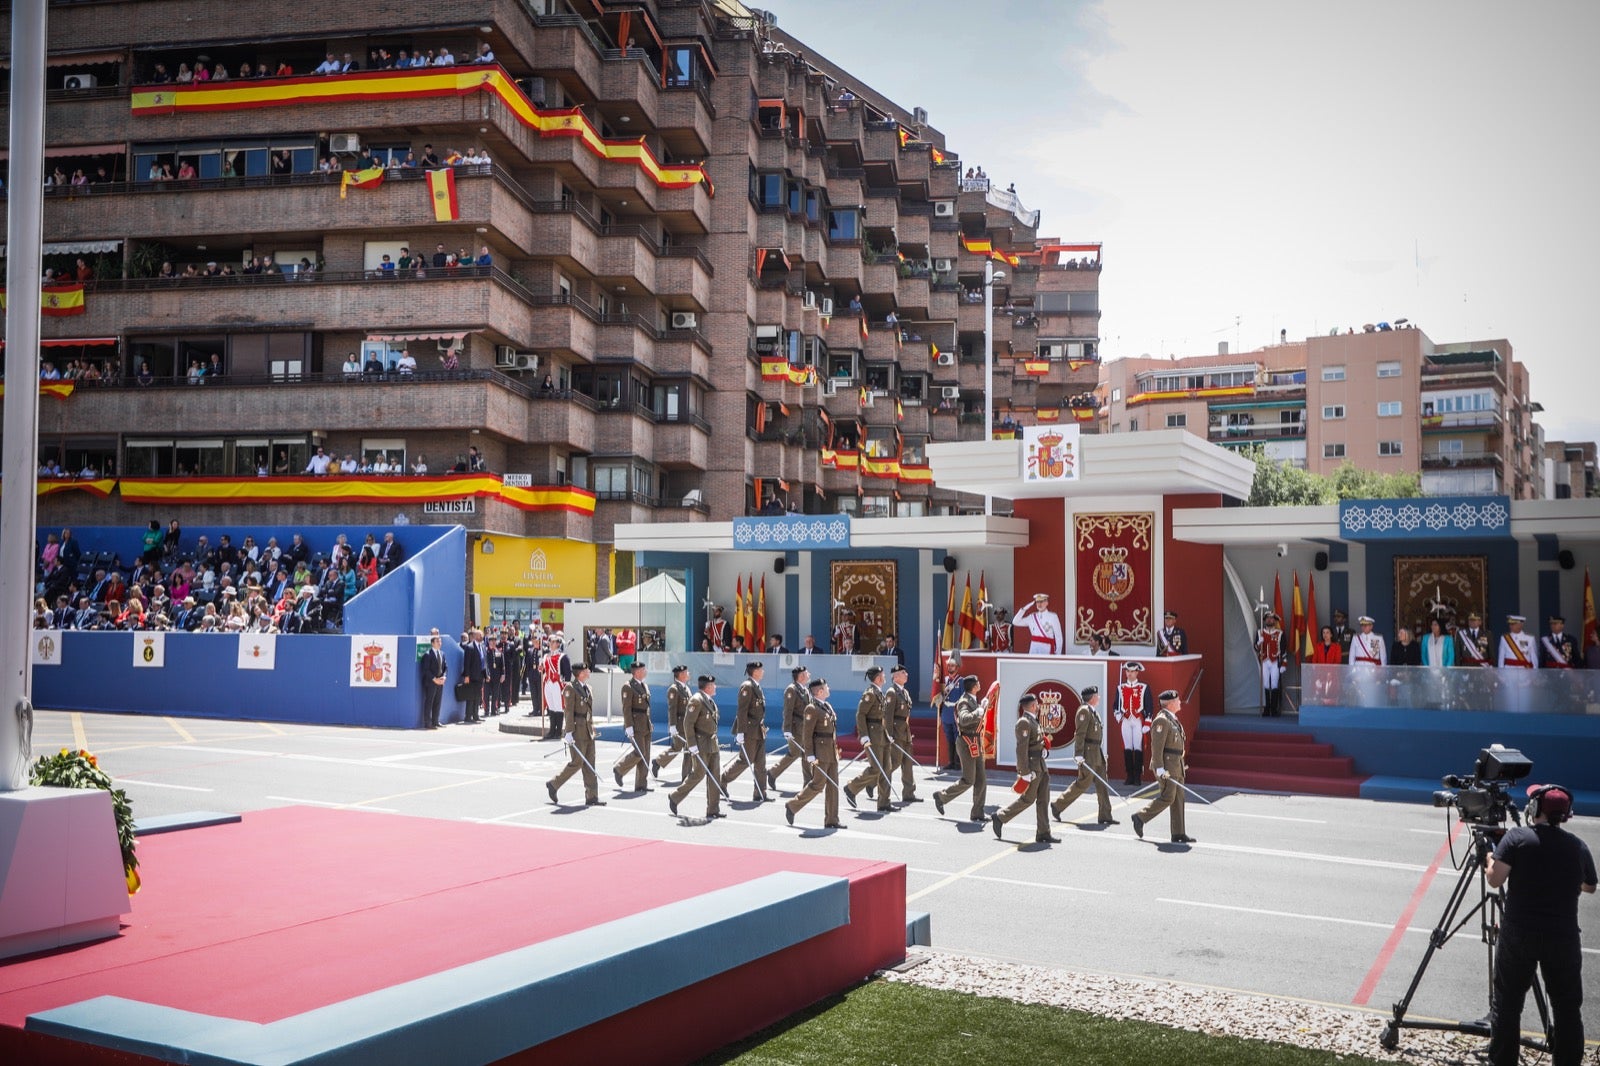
top-left (1485, 784), bottom-right (1595, 1066)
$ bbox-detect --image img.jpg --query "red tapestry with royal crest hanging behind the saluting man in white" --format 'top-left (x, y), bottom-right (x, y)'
top-left (1070, 511), bottom-right (1155, 643)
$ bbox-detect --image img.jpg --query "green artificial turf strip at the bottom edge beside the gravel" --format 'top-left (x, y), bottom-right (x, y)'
top-left (702, 981), bottom-right (1378, 1066)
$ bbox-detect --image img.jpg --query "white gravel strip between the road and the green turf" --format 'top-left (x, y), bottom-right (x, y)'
top-left (882, 949), bottom-right (1561, 1066)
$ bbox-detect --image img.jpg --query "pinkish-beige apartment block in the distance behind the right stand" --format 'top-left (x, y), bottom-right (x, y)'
top-left (1099, 328), bottom-right (1546, 499)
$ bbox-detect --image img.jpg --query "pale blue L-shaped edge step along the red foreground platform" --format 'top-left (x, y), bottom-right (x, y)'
top-left (26, 872), bottom-right (850, 1066)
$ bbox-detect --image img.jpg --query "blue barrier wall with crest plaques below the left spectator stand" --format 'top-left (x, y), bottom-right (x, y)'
top-left (34, 629), bottom-right (461, 728)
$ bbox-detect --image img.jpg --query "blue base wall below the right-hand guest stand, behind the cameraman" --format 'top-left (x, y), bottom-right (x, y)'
top-left (1299, 706), bottom-right (1600, 791)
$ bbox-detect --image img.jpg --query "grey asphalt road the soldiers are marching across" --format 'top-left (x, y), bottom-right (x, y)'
top-left (34, 712), bottom-right (1600, 1056)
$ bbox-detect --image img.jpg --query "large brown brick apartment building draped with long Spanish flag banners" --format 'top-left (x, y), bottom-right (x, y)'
top-left (0, 0), bottom-right (1099, 595)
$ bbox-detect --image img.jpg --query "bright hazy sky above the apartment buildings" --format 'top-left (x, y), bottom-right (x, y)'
top-left (762, 0), bottom-right (1600, 440)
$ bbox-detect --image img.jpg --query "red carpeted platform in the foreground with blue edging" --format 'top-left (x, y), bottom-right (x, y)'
top-left (0, 807), bottom-right (906, 1063)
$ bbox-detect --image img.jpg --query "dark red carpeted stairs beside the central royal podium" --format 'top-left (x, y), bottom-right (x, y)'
top-left (1189, 722), bottom-right (1366, 799)
